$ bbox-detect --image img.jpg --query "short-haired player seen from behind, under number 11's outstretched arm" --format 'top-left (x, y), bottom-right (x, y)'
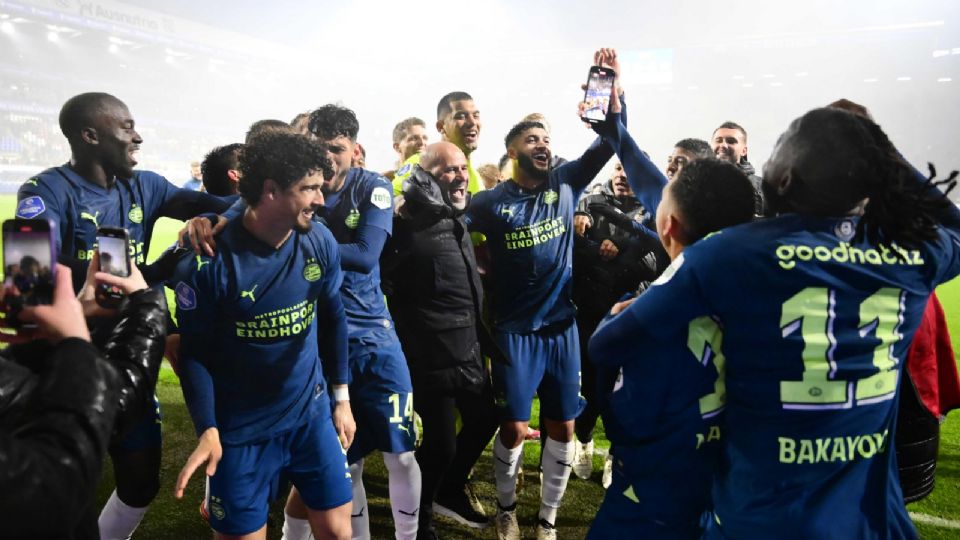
top-left (578, 158), bottom-right (754, 539)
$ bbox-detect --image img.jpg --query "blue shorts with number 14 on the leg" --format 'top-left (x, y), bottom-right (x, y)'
top-left (347, 329), bottom-right (415, 463)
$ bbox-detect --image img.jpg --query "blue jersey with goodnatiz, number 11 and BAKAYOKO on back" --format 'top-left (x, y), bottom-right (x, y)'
top-left (624, 212), bottom-right (960, 539)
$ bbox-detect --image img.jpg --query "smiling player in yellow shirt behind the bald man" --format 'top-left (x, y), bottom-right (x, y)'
top-left (393, 91), bottom-right (483, 195)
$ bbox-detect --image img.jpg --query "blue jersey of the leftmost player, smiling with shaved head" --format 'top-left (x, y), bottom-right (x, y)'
top-left (16, 165), bottom-right (230, 289)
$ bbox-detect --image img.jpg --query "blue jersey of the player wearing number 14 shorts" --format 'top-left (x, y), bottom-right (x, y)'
top-left (317, 168), bottom-right (393, 335)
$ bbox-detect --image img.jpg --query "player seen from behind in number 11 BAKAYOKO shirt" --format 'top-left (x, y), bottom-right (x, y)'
top-left (594, 109), bottom-right (960, 538)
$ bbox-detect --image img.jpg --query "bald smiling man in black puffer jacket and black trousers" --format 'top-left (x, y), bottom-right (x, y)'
top-left (381, 142), bottom-right (496, 538)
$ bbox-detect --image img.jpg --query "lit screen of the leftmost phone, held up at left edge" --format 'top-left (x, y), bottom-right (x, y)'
top-left (3, 223), bottom-right (54, 306)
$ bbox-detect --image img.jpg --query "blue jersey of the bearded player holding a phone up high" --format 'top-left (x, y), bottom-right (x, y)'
top-left (466, 139), bottom-right (613, 333)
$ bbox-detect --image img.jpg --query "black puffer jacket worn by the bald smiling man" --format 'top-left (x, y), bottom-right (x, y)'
top-left (380, 166), bottom-right (498, 388)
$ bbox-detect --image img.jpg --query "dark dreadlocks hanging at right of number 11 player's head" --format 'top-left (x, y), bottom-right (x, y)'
top-left (856, 116), bottom-right (960, 249)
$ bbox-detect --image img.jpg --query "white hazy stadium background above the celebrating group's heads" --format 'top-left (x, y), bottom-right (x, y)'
top-left (0, 0), bottom-right (960, 198)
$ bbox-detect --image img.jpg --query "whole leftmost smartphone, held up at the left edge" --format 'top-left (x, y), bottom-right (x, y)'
top-left (0, 218), bottom-right (57, 320)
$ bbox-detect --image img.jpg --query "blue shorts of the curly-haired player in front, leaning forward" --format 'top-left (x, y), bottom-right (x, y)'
top-left (204, 407), bottom-right (352, 535)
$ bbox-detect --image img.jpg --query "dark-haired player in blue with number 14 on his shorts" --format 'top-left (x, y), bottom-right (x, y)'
top-left (284, 105), bottom-right (420, 540)
